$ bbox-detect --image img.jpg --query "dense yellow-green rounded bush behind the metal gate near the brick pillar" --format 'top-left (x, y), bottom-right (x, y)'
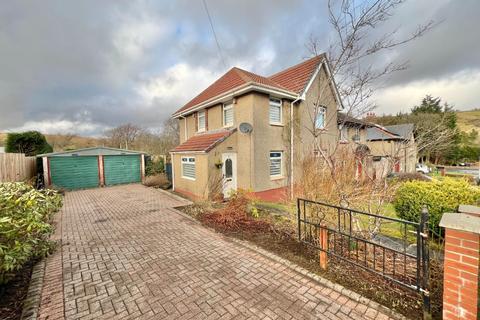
top-left (394, 178), bottom-right (480, 231)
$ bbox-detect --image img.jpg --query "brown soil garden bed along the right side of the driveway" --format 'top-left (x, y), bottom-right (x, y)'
top-left (180, 200), bottom-right (442, 319)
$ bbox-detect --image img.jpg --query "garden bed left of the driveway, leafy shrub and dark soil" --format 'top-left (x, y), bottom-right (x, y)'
top-left (0, 182), bottom-right (62, 319)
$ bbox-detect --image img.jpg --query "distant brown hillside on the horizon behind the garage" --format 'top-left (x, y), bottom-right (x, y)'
top-left (0, 133), bottom-right (104, 151)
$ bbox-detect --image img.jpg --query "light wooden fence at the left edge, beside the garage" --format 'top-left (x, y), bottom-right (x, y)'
top-left (0, 153), bottom-right (37, 182)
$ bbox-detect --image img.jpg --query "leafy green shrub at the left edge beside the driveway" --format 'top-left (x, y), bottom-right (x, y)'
top-left (0, 182), bottom-right (62, 285)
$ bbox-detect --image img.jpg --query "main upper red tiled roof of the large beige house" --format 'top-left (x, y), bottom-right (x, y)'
top-left (171, 55), bottom-right (323, 114)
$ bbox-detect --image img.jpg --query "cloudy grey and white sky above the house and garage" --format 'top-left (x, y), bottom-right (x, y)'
top-left (0, 0), bottom-right (480, 135)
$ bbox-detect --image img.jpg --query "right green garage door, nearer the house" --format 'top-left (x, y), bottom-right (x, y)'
top-left (103, 155), bottom-right (141, 186)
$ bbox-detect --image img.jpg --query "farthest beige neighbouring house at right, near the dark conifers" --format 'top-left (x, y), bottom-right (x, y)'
top-left (367, 123), bottom-right (418, 176)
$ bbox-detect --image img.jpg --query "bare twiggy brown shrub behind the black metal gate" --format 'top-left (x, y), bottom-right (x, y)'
top-left (298, 148), bottom-right (397, 237)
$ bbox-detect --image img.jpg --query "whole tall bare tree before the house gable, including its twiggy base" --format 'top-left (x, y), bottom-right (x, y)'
top-left (301, 0), bottom-right (434, 215)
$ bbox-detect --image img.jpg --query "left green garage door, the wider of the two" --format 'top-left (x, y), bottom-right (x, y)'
top-left (49, 156), bottom-right (99, 189)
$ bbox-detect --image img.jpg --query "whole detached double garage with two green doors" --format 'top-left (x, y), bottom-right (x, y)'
top-left (38, 147), bottom-right (145, 190)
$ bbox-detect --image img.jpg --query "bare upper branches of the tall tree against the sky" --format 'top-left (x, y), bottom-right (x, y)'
top-left (307, 0), bottom-right (434, 116)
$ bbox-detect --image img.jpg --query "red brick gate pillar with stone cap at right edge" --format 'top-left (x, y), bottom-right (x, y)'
top-left (440, 206), bottom-right (480, 320)
